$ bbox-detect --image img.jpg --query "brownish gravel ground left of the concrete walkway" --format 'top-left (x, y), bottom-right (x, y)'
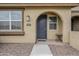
top-left (0, 43), bottom-right (34, 56)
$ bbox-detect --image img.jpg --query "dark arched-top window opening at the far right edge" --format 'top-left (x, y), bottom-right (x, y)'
top-left (71, 16), bottom-right (79, 31)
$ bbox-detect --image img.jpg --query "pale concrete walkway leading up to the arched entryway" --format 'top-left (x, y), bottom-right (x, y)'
top-left (30, 44), bottom-right (52, 56)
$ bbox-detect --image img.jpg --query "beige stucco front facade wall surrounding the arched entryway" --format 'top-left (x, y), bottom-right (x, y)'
top-left (0, 7), bottom-right (71, 43)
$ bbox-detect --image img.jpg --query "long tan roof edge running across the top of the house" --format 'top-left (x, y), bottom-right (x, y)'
top-left (0, 3), bottom-right (79, 7)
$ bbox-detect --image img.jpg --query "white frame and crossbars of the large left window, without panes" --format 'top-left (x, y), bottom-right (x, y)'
top-left (0, 9), bottom-right (22, 32)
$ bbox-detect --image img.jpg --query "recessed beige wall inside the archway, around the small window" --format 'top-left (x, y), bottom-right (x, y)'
top-left (47, 13), bottom-right (63, 40)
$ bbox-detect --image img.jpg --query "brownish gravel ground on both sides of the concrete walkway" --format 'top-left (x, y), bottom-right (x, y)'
top-left (0, 43), bottom-right (79, 56)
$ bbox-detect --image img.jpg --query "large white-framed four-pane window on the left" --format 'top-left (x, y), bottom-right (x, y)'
top-left (0, 10), bottom-right (22, 32)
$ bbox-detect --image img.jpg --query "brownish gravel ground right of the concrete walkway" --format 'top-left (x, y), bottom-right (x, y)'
top-left (49, 44), bottom-right (79, 56)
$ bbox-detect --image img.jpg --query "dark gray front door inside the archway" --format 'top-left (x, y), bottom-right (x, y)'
top-left (37, 15), bottom-right (47, 40)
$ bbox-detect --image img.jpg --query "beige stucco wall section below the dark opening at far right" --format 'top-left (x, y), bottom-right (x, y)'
top-left (70, 31), bottom-right (79, 50)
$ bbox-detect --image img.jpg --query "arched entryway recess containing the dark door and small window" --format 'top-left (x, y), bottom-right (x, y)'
top-left (36, 12), bottom-right (63, 41)
